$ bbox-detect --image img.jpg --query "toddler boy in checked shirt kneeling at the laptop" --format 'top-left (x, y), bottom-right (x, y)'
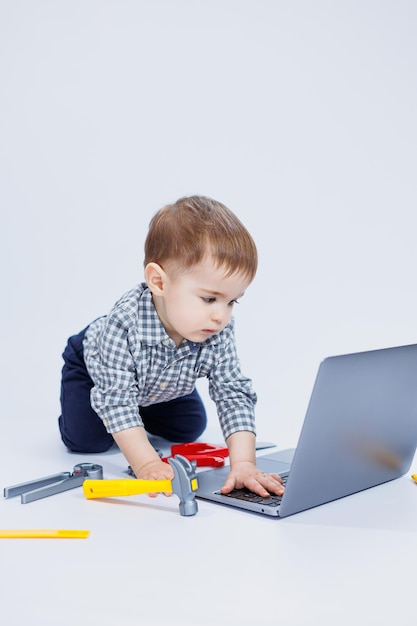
top-left (59, 196), bottom-right (284, 497)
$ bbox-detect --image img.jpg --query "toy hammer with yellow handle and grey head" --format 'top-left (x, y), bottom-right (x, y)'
top-left (83, 454), bottom-right (198, 515)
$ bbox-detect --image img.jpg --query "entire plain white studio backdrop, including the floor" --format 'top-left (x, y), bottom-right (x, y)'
top-left (0, 0), bottom-right (417, 626)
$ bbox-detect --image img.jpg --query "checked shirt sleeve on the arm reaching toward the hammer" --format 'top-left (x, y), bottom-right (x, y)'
top-left (84, 308), bottom-right (143, 433)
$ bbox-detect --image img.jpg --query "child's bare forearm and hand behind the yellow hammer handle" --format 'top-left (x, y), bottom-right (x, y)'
top-left (112, 426), bottom-right (174, 480)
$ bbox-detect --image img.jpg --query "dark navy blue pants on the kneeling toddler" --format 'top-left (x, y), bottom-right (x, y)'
top-left (58, 329), bottom-right (207, 453)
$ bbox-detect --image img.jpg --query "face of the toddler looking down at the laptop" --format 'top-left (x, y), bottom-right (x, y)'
top-left (155, 258), bottom-right (250, 346)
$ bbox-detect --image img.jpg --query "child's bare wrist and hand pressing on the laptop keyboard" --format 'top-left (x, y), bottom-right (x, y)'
top-left (221, 431), bottom-right (284, 498)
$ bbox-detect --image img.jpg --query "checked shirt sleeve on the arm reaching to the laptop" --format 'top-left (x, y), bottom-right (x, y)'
top-left (208, 323), bottom-right (257, 439)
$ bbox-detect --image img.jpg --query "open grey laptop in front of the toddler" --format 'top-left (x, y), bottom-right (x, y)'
top-left (196, 345), bottom-right (417, 518)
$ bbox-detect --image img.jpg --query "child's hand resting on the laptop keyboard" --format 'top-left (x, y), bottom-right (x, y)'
top-left (220, 461), bottom-right (284, 498)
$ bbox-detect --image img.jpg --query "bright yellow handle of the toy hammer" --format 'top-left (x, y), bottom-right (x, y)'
top-left (83, 478), bottom-right (172, 500)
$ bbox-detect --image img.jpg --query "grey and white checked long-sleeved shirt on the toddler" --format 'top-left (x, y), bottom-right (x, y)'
top-left (83, 283), bottom-right (256, 439)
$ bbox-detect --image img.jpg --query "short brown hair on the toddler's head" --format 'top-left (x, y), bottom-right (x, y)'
top-left (144, 196), bottom-right (258, 281)
